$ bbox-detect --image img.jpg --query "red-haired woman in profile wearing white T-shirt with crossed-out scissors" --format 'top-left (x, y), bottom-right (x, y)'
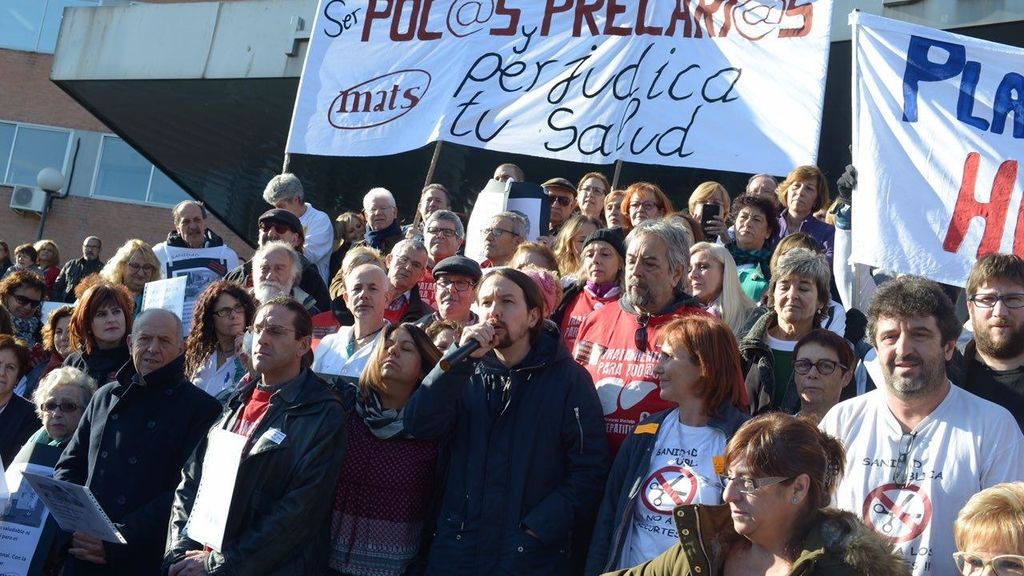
top-left (585, 316), bottom-right (748, 574)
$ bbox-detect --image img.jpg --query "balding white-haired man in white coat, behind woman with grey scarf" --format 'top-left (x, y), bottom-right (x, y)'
top-left (313, 264), bottom-right (391, 378)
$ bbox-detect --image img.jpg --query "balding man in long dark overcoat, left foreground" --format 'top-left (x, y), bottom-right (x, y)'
top-left (53, 308), bottom-right (220, 575)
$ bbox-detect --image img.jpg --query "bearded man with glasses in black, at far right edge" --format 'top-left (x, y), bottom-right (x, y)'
top-left (962, 254), bottom-right (1024, 429)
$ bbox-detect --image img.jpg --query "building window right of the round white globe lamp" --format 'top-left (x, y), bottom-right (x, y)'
top-left (92, 135), bottom-right (190, 206)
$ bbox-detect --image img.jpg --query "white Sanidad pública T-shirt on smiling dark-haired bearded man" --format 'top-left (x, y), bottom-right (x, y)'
top-left (820, 384), bottom-right (1024, 576)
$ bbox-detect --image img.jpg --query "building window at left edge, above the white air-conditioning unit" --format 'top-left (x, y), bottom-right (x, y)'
top-left (0, 122), bottom-right (71, 186)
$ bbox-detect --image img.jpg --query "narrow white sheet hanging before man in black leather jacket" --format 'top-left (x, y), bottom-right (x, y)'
top-left (185, 428), bottom-right (246, 551)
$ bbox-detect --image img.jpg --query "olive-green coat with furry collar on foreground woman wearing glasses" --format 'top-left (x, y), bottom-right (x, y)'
top-left (609, 504), bottom-right (910, 576)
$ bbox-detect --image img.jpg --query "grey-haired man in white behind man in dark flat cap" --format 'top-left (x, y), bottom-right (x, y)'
top-left (263, 173), bottom-right (334, 282)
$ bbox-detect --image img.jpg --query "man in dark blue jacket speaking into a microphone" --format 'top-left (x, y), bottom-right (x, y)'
top-left (404, 268), bottom-right (608, 575)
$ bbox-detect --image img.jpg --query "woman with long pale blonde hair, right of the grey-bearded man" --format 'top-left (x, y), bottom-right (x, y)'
top-left (688, 242), bottom-right (757, 334)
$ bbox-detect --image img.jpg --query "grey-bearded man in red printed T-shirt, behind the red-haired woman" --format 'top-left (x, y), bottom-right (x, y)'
top-left (574, 219), bottom-right (708, 456)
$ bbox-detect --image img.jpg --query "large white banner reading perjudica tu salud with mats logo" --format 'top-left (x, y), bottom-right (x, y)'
top-left (287, 0), bottom-right (833, 174)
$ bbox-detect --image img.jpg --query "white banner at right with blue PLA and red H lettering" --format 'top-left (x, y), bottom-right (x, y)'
top-left (850, 12), bottom-right (1024, 286)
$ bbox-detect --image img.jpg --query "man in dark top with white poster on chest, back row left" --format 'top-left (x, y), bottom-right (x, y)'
top-left (153, 200), bottom-right (239, 324)
